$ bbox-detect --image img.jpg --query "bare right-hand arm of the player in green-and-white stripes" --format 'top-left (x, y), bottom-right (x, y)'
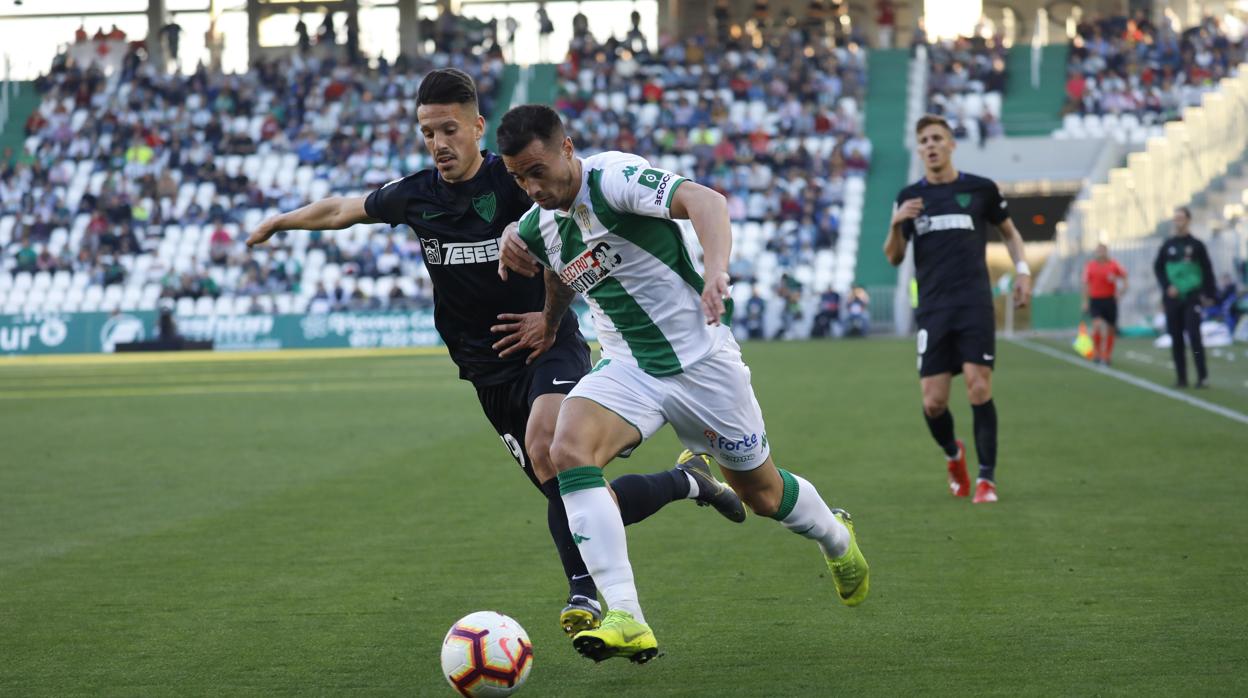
top-left (671, 181), bottom-right (733, 325)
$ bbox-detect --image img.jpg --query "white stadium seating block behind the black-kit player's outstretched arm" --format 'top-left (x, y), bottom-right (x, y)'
top-left (0, 56), bottom-right (502, 315)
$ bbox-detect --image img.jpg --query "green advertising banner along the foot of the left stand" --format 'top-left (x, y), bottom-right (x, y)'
top-left (0, 308), bottom-right (594, 356)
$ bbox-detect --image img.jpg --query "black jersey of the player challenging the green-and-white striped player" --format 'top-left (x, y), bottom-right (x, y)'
top-left (364, 151), bottom-right (579, 386)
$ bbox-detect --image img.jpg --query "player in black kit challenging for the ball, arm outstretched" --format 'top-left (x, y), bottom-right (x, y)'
top-left (247, 69), bottom-right (745, 636)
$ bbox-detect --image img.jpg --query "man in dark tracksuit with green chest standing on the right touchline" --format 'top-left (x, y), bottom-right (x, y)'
top-left (1153, 206), bottom-right (1218, 388)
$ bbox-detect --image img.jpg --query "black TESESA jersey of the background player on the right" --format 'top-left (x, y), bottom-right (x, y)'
top-left (897, 172), bottom-right (1010, 313)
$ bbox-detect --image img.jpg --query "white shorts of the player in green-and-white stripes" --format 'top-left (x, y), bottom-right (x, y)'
top-left (568, 341), bottom-right (770, 471)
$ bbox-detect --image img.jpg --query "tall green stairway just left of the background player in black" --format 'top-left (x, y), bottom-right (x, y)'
top-left (856, 49), bottom-right (910, 286)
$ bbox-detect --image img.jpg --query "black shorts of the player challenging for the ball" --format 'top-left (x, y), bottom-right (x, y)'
top-left (477, 332), bottom-right (590, 487)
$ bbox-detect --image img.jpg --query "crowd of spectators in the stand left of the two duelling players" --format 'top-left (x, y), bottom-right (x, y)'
top-left (0, 44), bottom-right (503, 312)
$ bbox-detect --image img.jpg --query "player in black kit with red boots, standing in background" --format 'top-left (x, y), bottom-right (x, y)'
top-left (884, 115), bottom-right (1031, 503)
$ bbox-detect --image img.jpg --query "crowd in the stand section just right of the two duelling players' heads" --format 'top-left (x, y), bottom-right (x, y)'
top-left (555, 17), bottom-right (871, 322)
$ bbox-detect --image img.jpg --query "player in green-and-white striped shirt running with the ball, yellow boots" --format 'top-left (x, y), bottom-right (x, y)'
top-left (498, 105), bottom-right (869, 663)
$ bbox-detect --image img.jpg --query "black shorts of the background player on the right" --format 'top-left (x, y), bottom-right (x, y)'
top-left (917, 307), bottom-right (997, 377)
